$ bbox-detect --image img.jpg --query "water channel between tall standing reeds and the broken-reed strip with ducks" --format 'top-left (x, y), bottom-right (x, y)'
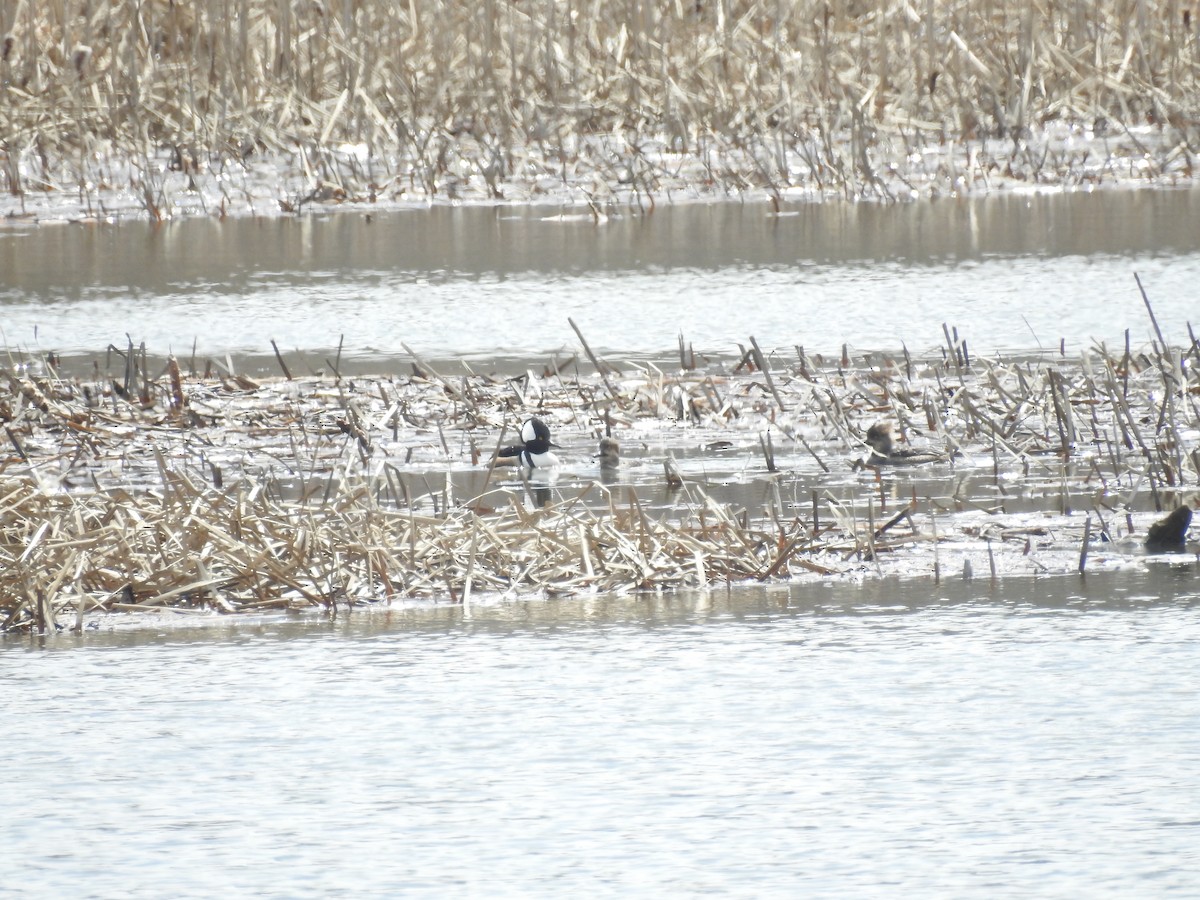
top-left (0, 190), bottom-right (1200, 371)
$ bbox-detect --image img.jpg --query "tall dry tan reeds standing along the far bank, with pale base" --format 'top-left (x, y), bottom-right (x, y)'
top-left (0, 0), bottom-right (1200, 217)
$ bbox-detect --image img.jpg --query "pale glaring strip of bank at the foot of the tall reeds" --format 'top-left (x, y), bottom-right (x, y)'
top-left (0, 127), bottom-right (1200, 227)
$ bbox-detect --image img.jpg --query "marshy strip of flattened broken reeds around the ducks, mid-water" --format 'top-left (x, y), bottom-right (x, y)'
top-left (0, 328), bottom-right (1200, 630)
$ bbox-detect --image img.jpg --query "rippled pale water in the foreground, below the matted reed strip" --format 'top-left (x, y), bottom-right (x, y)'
top-left (0, 573), bottom-right (1200, 898)
